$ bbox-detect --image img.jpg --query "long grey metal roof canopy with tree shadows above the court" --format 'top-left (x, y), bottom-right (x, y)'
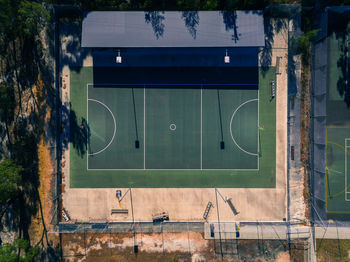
top-left (82, 11), bottom-right (265, 48)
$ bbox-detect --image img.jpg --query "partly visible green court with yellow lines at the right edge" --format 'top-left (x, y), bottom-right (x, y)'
top-left (325, 19), bottom-right (350, 216)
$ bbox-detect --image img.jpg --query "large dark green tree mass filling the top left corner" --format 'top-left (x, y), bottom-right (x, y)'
top-left (0, 0), bottom-right (50, 115)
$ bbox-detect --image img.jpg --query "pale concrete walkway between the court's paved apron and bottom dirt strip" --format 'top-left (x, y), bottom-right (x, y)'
top-left (58, 221), bottom-right (350, 240)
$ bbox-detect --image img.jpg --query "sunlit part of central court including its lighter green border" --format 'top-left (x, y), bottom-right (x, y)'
top-left (70, 67), bottom-right (276, 187)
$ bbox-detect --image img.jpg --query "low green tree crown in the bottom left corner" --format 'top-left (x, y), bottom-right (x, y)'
top-left (0, 238), bottom-right (39, 262)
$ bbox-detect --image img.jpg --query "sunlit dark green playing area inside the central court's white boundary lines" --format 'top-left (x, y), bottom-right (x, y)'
top-left (87, 84), bottom-right (259, 170)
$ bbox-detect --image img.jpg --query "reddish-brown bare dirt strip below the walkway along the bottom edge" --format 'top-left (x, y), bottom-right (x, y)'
top-left (61, 233), bottom-right (305, 262)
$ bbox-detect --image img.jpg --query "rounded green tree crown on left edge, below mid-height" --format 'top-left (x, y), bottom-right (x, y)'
top-left (0, 159), bottom-right (23, 205)
